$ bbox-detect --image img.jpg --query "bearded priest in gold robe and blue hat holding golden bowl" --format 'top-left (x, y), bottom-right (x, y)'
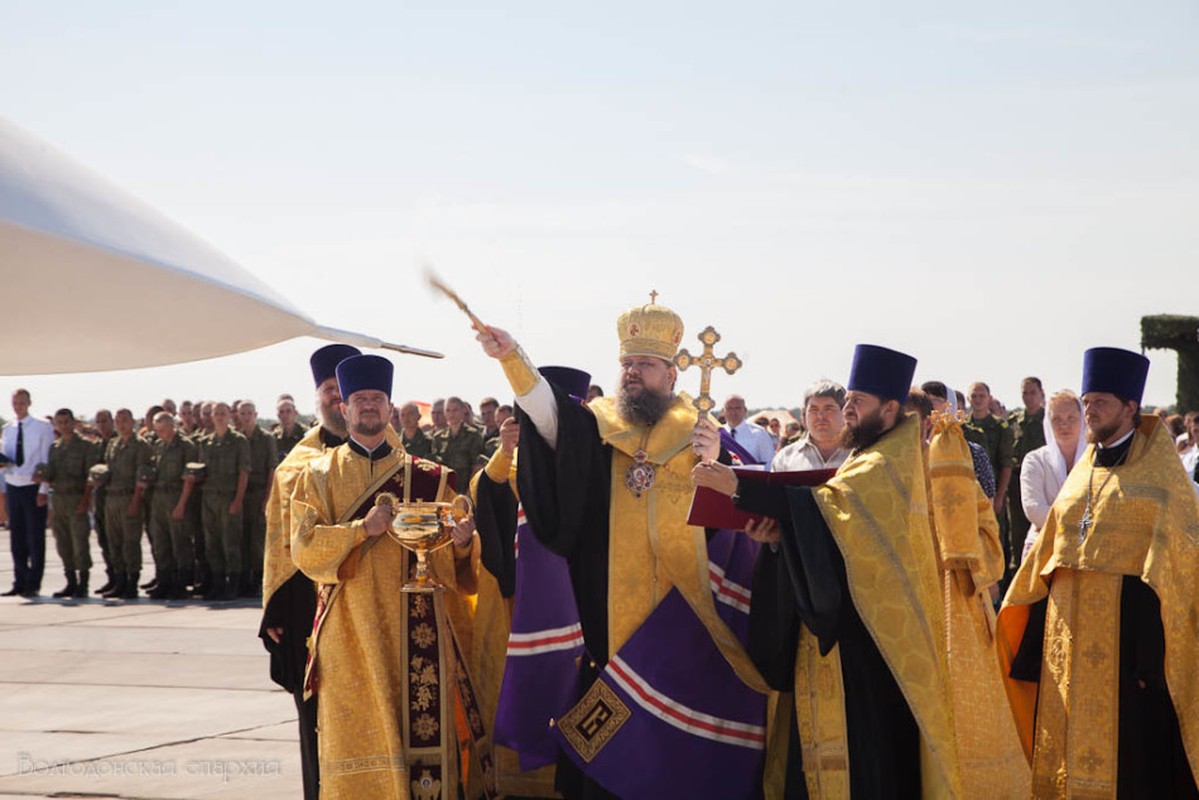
top-left (291, 355), bottom-right (478, 800)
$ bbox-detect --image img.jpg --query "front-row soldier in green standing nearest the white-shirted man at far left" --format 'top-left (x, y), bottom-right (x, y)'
top-left (42, 408), bottom-right (97, 597)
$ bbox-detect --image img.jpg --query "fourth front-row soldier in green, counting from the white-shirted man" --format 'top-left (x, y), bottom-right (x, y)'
top-left (200, 403), bottom-right (249, 600)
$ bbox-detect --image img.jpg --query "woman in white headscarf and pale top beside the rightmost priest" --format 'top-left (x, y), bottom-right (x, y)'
top-left (1020, 389), bottom-right (1086, 555)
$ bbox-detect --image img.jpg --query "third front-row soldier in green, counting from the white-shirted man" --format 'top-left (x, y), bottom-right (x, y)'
top-left (150, 411), bottom-right (199, 600)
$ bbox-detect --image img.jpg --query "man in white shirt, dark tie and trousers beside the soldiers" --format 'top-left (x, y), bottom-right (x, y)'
top-left (0, 389), bottom-right (54, 597)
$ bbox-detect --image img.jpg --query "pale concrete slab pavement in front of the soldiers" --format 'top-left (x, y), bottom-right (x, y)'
top-left (0, 530), bottom-right (301, 800)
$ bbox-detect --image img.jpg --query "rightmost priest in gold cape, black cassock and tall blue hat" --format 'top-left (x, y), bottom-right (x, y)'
top-left (996, 348), bottom-right (1199, 799)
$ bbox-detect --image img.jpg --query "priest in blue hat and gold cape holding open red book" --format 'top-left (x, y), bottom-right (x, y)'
top-left (694, 344), bottom-right (963, 800)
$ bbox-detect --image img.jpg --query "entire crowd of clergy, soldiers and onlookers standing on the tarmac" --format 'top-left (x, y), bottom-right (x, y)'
top-left (0, 302), bottom-right (1199, 798)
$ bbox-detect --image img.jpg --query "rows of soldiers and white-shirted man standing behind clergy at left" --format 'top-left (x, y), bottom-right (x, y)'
top-left (0, 389), bottom-right (529, 601)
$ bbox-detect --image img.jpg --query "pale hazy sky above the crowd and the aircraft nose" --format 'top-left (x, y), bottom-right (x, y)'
top-left (0, 0), bottom-right (1199, 415)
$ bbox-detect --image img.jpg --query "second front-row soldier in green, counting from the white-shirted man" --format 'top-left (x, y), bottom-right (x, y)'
top-left (103, 408), bottom-right (150, 600)
